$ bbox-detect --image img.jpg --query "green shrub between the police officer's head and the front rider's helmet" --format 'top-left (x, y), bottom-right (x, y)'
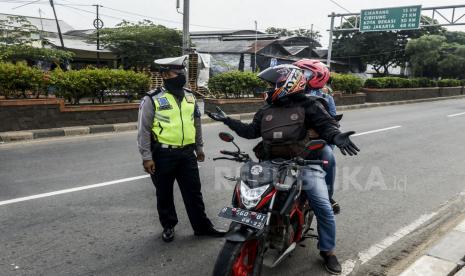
top-left (208, 71), bottom-right (267, 98)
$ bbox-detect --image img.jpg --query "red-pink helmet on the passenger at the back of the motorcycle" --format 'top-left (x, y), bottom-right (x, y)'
top-left (294, 59), bottom-right (331, 89)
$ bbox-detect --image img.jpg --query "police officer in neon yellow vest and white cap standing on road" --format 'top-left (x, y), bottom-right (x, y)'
top-left (137, 56), bottom-right (225, 242)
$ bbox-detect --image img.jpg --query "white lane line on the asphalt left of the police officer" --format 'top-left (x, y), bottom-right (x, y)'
top-left (0, 174), bottom-right (150, 206)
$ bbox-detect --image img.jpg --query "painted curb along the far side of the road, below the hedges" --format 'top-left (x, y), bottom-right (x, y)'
top-left (0, 95), bottom-right (465, 143)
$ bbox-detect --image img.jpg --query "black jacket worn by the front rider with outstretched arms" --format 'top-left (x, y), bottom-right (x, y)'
top-left (225, 94), bottom-right (341, 143)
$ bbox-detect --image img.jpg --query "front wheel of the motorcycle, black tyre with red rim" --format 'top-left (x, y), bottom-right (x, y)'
top-left (213, 240), bottom-right (263, 276)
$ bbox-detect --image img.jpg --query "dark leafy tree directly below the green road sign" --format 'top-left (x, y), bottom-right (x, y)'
top-left (333, 16), bottom-right (444, 75)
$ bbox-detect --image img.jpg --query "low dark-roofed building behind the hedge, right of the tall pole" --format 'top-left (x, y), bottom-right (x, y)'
top-left (191, 30), bottom-right (361, 74)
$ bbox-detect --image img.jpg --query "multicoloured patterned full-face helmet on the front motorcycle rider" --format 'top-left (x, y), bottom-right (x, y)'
top-left (258, 64), bottom-right (307, 102)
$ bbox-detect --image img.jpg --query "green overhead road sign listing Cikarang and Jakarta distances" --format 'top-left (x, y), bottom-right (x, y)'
top-left (360, 6), bottom-right (421, 32)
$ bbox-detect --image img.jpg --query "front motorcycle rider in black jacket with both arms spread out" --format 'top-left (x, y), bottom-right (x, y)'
top-left (206, 65), bottom-right (359, 274)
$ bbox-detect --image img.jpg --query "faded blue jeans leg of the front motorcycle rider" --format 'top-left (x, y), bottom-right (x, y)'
top-left (300, 166), bottom-right (336, 251)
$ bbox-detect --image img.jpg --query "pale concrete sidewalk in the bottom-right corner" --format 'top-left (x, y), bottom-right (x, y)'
top-left (400, 220), bottom-right (465, 276)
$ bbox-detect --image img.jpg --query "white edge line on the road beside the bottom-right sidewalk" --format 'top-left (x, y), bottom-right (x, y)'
top-left (341, 212), bottom-right (437, 275)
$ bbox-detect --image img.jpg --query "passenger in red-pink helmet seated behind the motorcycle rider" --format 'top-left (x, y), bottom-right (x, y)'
top-left (294, 59), bottom-right (341, 214)
